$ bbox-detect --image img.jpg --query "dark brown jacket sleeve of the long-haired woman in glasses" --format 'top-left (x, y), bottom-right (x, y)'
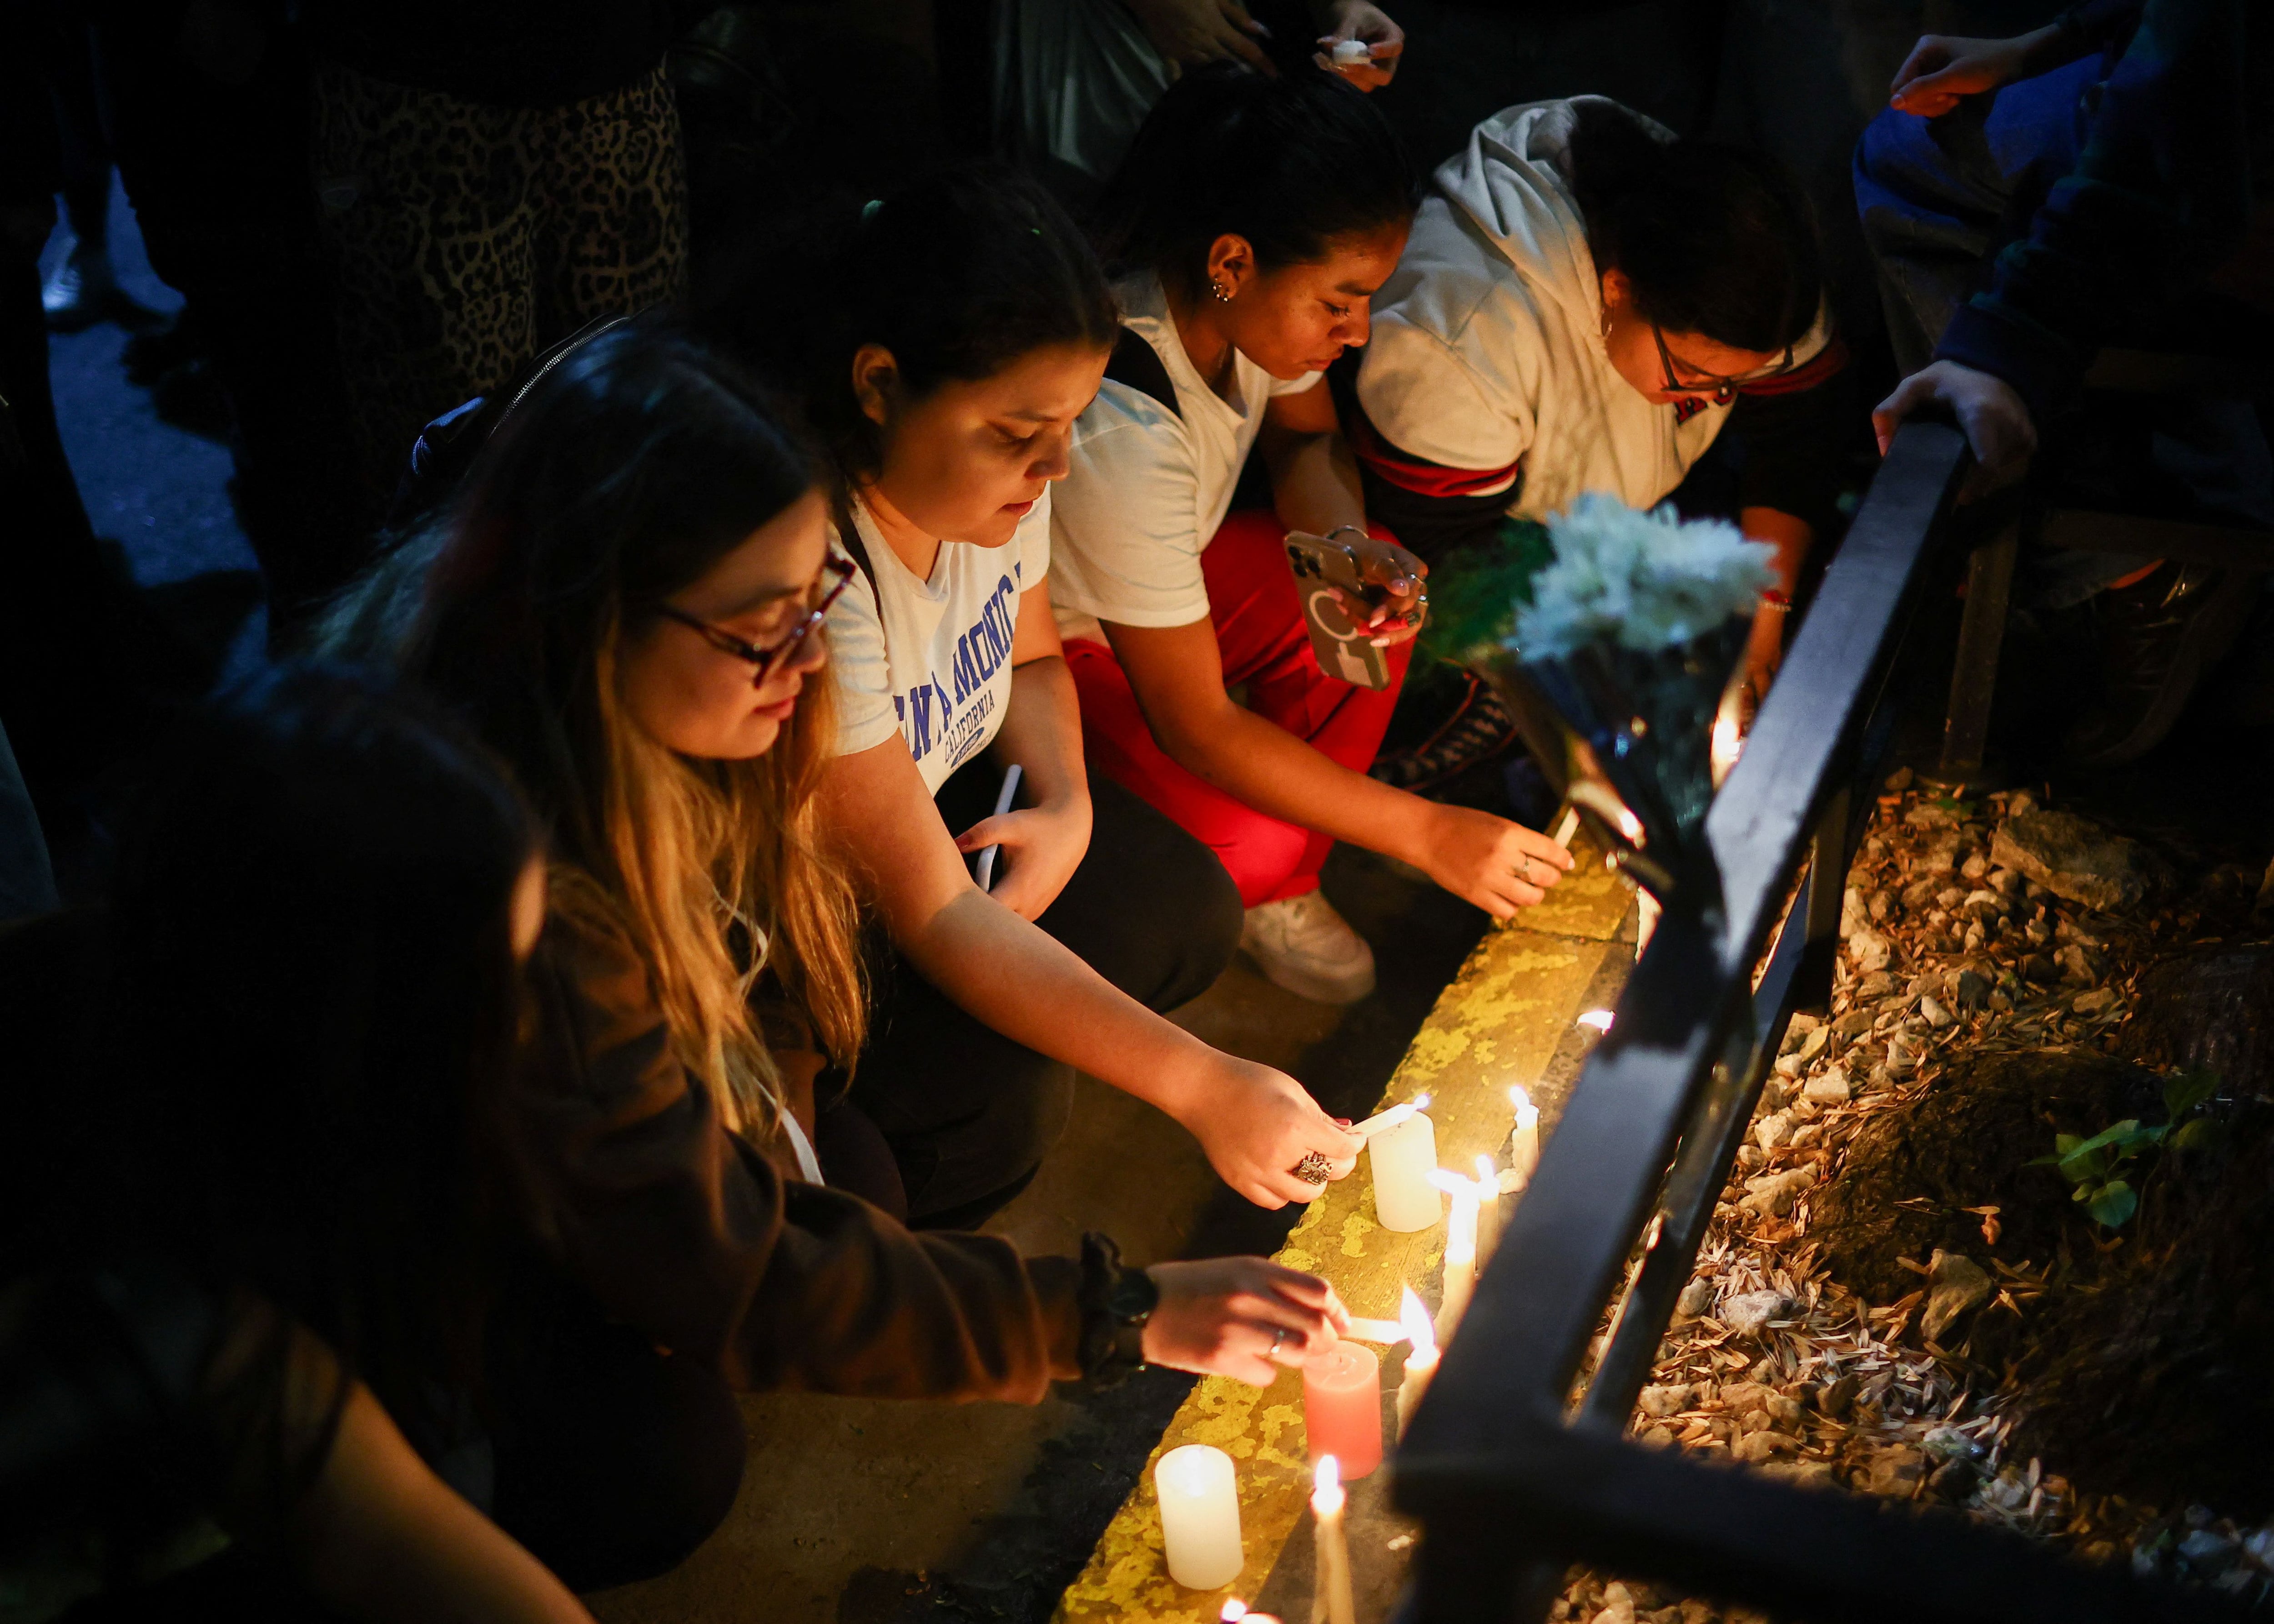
top-left (514, 915), bottom-right (1082, 1403)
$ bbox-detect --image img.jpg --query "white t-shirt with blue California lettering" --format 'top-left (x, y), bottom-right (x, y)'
top-left (828, 489), bottom-right (1051, 794)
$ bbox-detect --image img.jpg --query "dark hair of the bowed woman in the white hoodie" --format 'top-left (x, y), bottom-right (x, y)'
top-left (1571, 98), bottom-right (1824, 350)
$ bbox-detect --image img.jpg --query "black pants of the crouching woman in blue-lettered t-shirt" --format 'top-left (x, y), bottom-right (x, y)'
top-left (853, 762), bottom-right (1242, 1228)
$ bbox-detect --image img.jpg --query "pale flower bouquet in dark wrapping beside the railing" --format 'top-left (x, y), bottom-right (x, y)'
top-left (1494, 496), bottom-right (1776, 901)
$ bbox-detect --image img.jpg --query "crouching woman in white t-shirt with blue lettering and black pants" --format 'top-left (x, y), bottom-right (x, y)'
top-left (728, 168), bottom-right (1358, 1228)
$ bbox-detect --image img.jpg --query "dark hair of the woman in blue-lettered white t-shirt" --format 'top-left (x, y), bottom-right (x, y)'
top-left (703, 164), bottom-right (1119, 480)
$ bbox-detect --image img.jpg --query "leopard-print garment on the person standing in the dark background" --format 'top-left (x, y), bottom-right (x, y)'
top-left (316, 64), bottom-right (687, 500)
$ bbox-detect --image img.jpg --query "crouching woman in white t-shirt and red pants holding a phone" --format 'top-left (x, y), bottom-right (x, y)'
top-left (1051, 68), bottom-right (1569, 1003)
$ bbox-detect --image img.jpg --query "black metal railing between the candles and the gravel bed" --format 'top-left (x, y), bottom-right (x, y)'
top-left (1394, 423), bottom-right (2238, 1624)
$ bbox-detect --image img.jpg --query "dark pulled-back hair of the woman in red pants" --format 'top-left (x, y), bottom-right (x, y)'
top-left (1098, 64), bottom-right (1421, 298)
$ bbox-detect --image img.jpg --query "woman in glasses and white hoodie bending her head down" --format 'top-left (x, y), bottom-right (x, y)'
top-left (1351, 96), bottom-right (1846, 691)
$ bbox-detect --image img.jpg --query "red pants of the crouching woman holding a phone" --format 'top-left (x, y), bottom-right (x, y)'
top-left (1067, 512), bottom-right (1412, 908)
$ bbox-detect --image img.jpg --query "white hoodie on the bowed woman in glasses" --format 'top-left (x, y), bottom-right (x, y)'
top-left (1358, 96), bottom-right (1826, 518)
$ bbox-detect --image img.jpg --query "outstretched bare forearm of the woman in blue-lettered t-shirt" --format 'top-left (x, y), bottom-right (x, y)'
top-left (894, 892), bottom-right (1212, 1117)
